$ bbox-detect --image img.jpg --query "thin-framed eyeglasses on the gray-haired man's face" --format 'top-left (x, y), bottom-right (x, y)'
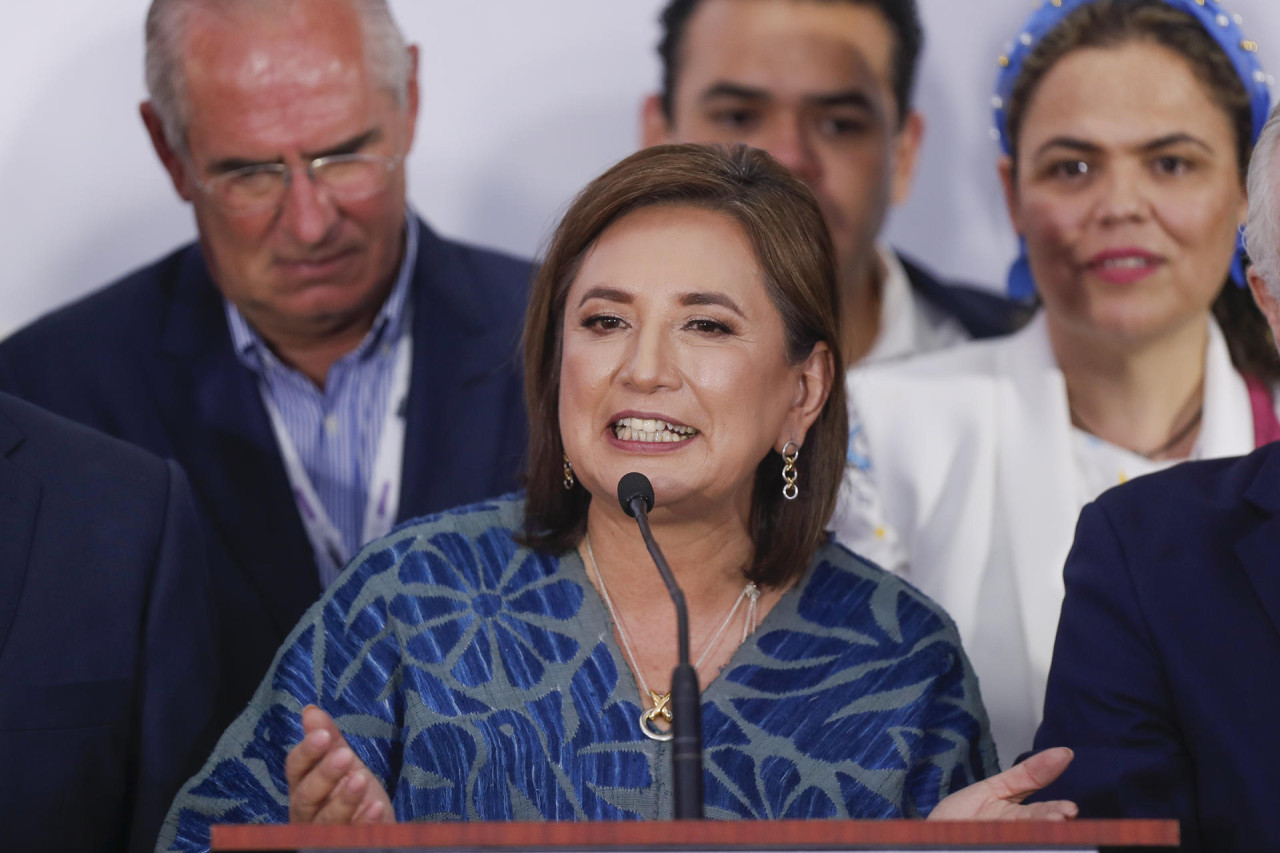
top-left (196, 154), bottom-right (404, 214)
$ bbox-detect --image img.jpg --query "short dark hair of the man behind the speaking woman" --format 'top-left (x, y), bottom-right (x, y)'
top-left (658, 0), bottom-right (924, 124)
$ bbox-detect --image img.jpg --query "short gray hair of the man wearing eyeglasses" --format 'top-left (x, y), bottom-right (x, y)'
top-left (146, 0), bottom-right (411, 151)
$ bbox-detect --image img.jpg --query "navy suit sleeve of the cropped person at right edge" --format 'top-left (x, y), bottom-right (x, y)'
top-left (1036, 503), bottom-right (1198, 849)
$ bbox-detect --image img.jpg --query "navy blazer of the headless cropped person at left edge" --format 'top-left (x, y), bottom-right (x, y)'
top-left (0, 394), bottom-right (216, 852)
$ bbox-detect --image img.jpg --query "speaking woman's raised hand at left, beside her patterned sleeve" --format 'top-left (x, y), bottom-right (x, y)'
top-left (284, 704), bottom-right (396, 824)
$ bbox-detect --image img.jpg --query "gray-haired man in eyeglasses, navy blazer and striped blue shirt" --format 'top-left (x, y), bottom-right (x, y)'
top-left (0, 0), bottom-right (530, 732)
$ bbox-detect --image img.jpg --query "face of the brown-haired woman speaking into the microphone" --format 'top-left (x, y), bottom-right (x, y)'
top-left (559, 206), bottom-right (831, 519)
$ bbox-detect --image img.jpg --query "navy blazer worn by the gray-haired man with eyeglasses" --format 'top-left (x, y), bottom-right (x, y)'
top-left (0, 222), bottom-right (530, 722)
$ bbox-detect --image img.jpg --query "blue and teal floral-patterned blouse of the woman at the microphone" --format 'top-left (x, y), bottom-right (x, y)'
top-left (160, 498), bottom-right (996, 850)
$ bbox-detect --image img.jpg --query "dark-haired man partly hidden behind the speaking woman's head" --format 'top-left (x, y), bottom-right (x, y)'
top-left (643, 0), bottom-right (1027, 365)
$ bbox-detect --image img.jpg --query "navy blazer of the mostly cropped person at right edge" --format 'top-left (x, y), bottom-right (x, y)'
top-left (1036, 443), bottom-right (1280, 850)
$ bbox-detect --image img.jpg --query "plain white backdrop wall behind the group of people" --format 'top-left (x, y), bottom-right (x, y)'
top-left (0, 0), bottom-right (1280, 337)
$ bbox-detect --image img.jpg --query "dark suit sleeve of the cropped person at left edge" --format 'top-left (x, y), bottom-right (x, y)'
top-left (129, 461), bottom-right (218, 850)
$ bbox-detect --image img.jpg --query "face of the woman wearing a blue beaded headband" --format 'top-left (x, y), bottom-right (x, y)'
top-left (1002, 42), bottom-right (1247, 345)
